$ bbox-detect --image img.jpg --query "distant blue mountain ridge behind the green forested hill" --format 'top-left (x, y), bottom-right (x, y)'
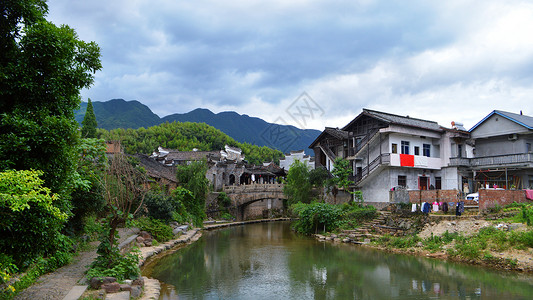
top-left (76, 99), bottom-right (321, 155)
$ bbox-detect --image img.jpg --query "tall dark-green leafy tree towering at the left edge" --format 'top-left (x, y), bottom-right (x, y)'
top-left (0, 0), bottom-right (101, 199)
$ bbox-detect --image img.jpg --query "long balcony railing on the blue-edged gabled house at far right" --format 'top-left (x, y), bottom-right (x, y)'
top-left (450, 153), bottom-right (533, 167)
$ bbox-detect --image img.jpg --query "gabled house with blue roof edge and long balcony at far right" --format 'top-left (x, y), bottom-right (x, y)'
top-left (450, 110), bottom-right (533, 192)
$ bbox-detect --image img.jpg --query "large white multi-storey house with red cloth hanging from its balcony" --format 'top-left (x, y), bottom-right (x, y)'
top-left (310, 109), bottom-right (469, 202)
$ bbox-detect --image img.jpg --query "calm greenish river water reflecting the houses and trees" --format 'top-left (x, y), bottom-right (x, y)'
top-left (144, 222), bottom-right (533, 299)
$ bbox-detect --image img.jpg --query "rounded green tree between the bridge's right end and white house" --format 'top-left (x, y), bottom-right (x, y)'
top-left (283, 160), bottom-right (311, 205)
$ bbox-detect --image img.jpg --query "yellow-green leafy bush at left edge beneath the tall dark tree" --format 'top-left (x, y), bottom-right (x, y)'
top-left (0, 170), bottom-right (67, 265)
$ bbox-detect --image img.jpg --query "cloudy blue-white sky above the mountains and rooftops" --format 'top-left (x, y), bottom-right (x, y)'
top-left (48, 0), bottom-right (533, 130)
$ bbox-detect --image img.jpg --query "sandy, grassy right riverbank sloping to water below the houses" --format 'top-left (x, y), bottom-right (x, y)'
top-left (315, 216), bottom-right (533, 273)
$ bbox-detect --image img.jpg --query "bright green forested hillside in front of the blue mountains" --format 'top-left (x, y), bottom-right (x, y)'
top-left (98, 122), bottom-right (283, 164)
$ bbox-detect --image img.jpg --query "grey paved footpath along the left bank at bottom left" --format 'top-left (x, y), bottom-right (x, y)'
top-left (15, 228), bottom-right (139, 300)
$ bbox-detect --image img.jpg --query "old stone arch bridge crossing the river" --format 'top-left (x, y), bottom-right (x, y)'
top-left (223, 184), bottom-right (287, 220)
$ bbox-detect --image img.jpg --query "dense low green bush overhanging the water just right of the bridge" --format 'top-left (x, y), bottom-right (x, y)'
top-left (291, 202), bottom-right (342, 234)
